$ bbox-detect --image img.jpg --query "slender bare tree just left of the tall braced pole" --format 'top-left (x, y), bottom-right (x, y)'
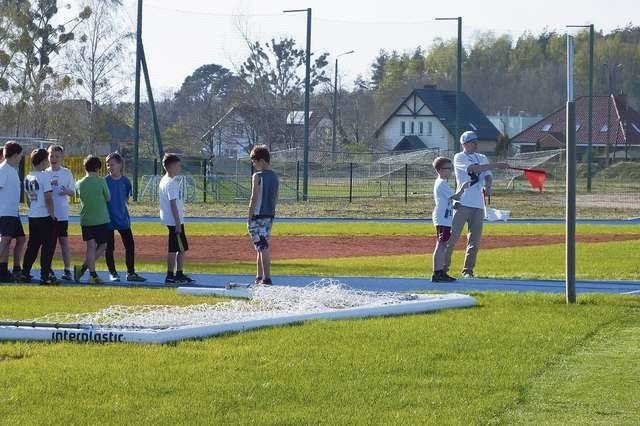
top-left (66, 0), bottom-right (134, 152)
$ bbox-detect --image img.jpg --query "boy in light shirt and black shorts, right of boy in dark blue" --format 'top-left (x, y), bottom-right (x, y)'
top-left (158, 154), bottom-right (195, 284)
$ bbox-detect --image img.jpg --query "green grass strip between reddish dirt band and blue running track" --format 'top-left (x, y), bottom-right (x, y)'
top-left (101, 240), bottom-right (640, 280)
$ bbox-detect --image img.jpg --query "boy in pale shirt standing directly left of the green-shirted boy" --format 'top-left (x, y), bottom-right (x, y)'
top-left (47, 145), bottom-right (76, 281)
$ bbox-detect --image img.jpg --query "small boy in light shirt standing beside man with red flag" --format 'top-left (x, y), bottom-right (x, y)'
top-left (431, 157), bottom-right (468, 283)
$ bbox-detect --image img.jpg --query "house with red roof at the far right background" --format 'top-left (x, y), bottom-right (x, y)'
top-left (511, 95), bottom-right (640, 158)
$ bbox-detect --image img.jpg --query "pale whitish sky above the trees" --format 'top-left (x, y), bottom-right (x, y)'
top-left (117, 0), bottom-right (640, 96)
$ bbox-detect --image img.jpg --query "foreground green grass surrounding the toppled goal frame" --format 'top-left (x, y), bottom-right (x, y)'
top-left (0, 287), bottom-right (640, 425)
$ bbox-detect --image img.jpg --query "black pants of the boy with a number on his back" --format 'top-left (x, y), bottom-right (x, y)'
top-left (22, 216), bottom-right (57, 278)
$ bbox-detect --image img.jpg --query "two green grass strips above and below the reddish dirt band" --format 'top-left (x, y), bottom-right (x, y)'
top-left (53, 222), bottom-right (640, 280)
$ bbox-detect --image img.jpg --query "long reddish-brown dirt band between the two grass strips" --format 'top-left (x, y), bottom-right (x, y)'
top-left (61, 234), bottom-right (640, 262)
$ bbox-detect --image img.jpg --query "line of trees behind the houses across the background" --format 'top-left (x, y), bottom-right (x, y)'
top-left (0, 0), bottom-right (640, 155)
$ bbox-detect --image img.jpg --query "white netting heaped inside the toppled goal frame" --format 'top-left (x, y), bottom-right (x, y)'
top-left (13, 279), bottom-right (416, 330)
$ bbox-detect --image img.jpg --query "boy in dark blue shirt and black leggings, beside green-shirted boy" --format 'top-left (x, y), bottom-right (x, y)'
top-left (105, 152), bottom-right (146, 282)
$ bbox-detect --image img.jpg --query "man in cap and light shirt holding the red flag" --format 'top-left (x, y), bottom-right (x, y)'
top-left (444, 131), bottom-right (508, 279)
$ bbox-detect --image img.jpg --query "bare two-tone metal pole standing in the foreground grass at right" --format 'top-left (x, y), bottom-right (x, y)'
top-left (565, 34), bottom-right (576, 304)
